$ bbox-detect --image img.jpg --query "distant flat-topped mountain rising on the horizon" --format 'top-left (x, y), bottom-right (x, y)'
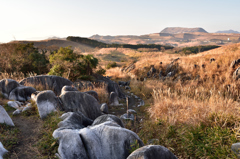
top-left (160, 27), bottom-right (208, 34)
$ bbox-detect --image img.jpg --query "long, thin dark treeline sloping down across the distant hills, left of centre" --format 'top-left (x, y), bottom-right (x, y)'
top-left (67, 36), bottom-right (173, 50)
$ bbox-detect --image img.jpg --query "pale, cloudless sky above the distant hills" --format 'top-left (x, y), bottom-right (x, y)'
top-left (0, 0), bottom-right (240, 42)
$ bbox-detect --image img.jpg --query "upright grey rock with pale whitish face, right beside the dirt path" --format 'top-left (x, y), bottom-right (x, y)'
top-left (36, 90), bottom-right (59, 119)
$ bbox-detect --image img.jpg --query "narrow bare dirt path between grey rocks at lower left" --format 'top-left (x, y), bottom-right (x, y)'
top-left (10, 115), bottom-right (43, 159)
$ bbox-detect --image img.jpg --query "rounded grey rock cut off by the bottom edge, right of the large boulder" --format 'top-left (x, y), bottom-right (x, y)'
top-left (127, 145), bottom-right (177, 159)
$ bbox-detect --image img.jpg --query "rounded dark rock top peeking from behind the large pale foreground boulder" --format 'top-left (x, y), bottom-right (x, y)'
top-left (92, 114), bottom-right (124, 128)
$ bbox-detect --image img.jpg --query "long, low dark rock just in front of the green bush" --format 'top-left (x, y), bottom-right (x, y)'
top-left (20, 75), bottom-right (73, 95)
